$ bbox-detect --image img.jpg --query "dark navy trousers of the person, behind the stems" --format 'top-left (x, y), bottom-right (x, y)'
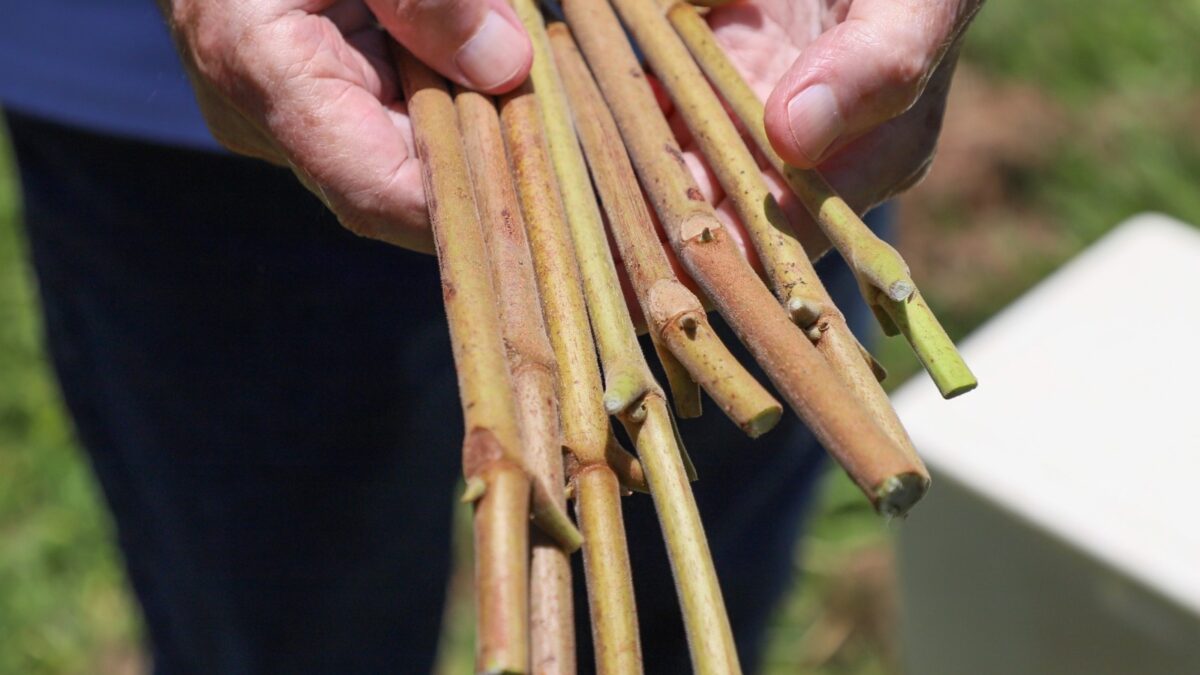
top-left (8, 115), bottom-right (883, 675)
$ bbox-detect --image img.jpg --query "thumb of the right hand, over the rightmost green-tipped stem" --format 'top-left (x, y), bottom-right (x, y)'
top-left (764, 0), bottom-right (979, 168)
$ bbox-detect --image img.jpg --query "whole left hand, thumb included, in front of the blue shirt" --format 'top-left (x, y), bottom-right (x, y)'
top-left (160, 0), bottom-right (533, 252)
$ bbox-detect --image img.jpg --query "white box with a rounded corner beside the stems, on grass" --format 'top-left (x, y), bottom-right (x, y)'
top-left (894, 214), bottom-right (1200, 675)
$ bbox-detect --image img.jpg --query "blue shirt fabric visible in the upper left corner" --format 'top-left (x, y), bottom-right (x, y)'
top-left (0, 0), bottom-right (220, 150)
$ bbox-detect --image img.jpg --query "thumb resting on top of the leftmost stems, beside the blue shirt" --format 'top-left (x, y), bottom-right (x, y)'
top-left (367, 0), bottom-right (533, 94)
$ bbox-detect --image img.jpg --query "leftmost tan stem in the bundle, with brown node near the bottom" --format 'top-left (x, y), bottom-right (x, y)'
top-left (395, 48), bottom-right (590, 673)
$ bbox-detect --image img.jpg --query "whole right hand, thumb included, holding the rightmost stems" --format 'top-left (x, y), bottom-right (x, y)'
top-left (677, 0), bottom-right (982, 227)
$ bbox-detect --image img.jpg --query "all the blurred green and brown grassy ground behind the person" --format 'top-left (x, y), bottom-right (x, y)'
top-left (0, 0), bottom-right (1200, 675)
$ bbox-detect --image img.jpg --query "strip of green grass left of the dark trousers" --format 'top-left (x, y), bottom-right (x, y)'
top-left (0, 127), bottom-right (138, 675)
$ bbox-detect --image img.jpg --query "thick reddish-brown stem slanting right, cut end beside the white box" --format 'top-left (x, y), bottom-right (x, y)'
top-left (564, 0), bottom-right (919, 512)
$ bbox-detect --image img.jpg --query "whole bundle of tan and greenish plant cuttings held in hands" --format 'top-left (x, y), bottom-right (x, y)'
top-left (396, 0), bottom-right (976, 674)
